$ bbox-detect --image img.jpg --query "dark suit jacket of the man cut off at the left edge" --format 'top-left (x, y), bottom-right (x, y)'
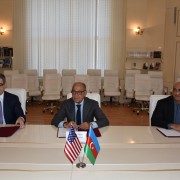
top-left (3, 91), bottom-right (26, 124)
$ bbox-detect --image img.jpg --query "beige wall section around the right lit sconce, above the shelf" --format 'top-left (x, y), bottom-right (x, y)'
top-left (126, 0), bottom-right (166, 51)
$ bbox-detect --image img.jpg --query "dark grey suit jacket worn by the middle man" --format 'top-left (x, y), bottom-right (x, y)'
top-left (51, 97), bottom-right (109, 127)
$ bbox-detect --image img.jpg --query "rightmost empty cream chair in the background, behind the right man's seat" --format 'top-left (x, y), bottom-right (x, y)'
top-left (148, 71), bottom-right (167, 95)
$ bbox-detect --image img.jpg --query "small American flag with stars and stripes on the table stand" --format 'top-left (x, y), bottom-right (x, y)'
top-left (64, 126), bottom-right (82, 164)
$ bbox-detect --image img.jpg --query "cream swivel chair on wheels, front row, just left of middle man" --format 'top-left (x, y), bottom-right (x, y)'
top-left (42, 73), bottom-right (62, 114)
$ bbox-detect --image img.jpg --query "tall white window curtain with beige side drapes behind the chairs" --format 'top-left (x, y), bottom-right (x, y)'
top-left (13, 0), bottom-right (125, 76)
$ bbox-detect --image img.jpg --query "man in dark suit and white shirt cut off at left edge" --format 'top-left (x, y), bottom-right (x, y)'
top-left (0, 73), bottom-right (26, 128)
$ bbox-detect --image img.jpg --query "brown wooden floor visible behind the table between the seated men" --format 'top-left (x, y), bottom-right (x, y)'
top-left (26, 103), bottom-right (149, 126)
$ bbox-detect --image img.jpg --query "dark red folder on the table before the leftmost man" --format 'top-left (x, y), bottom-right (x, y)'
top-left (0, 125), bottom-right (20, 137)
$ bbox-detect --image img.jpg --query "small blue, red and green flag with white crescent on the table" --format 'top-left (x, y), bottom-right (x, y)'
top-left (84, 127), bottom-right (100, 165)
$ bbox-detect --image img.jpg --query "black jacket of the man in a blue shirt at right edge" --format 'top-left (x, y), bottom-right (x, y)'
top-left (151, 96), bottom-right (174, 128)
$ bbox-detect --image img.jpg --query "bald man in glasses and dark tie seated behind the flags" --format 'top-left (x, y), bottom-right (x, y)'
top-left (51, 82), bottom-right (109, 130)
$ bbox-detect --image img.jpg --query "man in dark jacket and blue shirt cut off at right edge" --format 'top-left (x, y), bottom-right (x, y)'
top-left (151, 82), bottom-right (180, 131)
